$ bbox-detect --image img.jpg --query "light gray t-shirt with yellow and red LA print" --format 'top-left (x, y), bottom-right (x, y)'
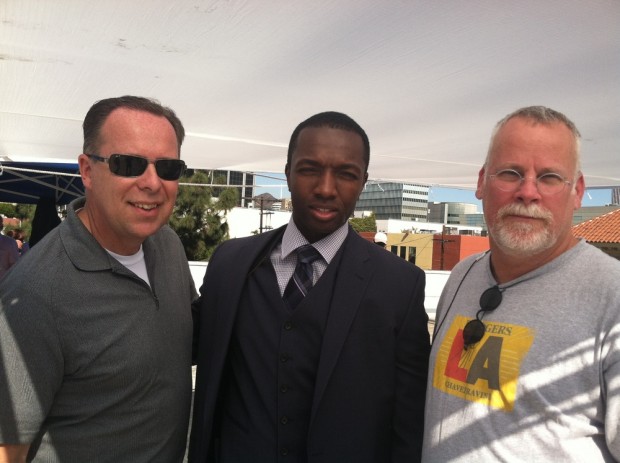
top-left (423, 241), bottom-right (620, 463)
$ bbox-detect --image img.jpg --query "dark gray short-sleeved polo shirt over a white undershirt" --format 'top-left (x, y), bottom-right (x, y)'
top-left (0, 200), bottom-right (196, 463)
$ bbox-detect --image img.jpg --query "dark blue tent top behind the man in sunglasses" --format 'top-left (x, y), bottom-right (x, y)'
top-left (0, 161), bottom-right (84, 205)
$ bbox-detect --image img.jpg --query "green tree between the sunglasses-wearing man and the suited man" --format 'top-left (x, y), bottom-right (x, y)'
top-left (170, 170), bottom-right (239, 260)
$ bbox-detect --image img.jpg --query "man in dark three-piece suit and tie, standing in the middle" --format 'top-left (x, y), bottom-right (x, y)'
top-left (189, 112), bottom-right (430, 463)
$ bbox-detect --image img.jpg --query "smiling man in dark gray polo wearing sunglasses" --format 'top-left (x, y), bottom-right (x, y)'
top-left (0, 96), bottom-right (197, 463)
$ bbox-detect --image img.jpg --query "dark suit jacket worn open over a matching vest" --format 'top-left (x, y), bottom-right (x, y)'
top-left (190, 227), bottom-right (430, 463)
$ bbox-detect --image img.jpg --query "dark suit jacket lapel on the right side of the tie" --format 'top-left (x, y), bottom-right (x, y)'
top-left (310, 232), bottom-right (373, 423)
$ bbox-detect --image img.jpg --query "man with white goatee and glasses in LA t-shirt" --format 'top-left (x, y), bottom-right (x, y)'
top-left (423, 106), bottom-right (620, 463)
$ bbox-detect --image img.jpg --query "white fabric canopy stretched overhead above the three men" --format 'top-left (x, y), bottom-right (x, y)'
top-left (0, 0), bottom-right (620, 188)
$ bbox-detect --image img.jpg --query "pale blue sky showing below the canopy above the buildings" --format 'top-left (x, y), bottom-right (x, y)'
top-left (255, 173), bottom-right (611, 212)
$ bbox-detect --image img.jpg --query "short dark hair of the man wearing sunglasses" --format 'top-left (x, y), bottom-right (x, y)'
top-left (82, 95), bottom-right (185, 154)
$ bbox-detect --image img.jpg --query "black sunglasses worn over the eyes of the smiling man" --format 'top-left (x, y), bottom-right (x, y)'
top-left (85, 153), bottom-right (185, 180)
